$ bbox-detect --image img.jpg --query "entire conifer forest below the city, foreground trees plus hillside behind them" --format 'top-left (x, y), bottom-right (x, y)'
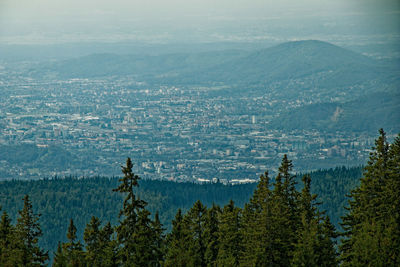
top-left (0, 130), bottom-right (400, 266)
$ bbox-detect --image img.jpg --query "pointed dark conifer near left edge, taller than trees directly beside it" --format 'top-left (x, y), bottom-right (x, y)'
top-left (15, 195), bottom-right (49, 266)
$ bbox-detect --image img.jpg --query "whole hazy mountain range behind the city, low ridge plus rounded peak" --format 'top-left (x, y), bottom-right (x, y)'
top-left (33, 40), bottom-right (398, 87)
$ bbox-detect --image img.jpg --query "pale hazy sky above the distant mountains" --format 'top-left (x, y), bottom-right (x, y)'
top-left (0, 0), bottom-right (400, 43)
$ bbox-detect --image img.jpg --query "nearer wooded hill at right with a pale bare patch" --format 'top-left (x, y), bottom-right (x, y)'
top-left (270, 92), bottom-right (400, 134)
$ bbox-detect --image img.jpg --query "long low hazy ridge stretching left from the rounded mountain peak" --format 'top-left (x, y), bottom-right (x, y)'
top-left (32, 50), bottom-right (247, 79)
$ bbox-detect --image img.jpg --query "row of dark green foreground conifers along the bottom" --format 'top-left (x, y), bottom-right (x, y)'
top-left (0, 130), bottom-right (400, 266)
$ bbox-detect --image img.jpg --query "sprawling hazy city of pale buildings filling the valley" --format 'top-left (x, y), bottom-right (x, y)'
top-left (0, 71), bottom-right (384, 183)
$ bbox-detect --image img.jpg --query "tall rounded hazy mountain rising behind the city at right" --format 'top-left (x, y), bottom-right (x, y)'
top-left (184, 40), bottom-right (396, 86)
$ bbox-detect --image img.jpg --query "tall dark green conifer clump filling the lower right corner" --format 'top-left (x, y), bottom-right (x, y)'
top-left (340, 129), bottom-right (400, 266)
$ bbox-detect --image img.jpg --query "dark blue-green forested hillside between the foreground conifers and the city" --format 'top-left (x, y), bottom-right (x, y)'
top-left (0, 164), bottom-right (362, 262)
